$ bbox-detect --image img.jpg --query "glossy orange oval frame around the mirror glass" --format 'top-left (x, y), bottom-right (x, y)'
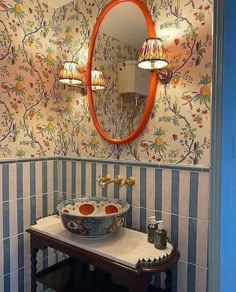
top-left (87, 0), bottom-right (157, 144)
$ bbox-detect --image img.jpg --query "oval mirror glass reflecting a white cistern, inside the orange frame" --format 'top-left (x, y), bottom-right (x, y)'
top-left (92, 2), bottom-right (150, 139)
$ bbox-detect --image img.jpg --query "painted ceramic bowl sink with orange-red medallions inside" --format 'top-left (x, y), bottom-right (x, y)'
top-left (57, 197), bottom-right (130, 239)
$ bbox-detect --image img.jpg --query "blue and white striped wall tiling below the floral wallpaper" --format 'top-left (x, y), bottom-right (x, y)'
top-left (0, 157), bottom-right (209, 292)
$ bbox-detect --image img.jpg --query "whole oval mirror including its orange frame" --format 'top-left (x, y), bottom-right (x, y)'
top-left (87, 0), bottom-right (157, 144)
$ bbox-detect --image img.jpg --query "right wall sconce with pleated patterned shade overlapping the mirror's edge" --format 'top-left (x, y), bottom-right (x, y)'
top-left (138, 38), bottom-right (172, 84)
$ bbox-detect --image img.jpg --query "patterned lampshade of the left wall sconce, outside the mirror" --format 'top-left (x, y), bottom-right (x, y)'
top-left (59, 61), bottom-right (83, 86)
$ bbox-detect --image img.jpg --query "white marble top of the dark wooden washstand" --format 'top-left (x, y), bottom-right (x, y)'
top-left (30, 215), bottom-right (172, 268)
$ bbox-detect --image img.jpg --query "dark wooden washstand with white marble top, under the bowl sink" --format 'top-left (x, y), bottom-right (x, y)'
top-left (27, 215), bottom-right (180, 292)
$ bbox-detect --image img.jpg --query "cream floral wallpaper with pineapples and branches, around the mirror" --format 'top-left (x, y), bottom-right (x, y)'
top-left (0, 0), bottom-right (213, 165)
